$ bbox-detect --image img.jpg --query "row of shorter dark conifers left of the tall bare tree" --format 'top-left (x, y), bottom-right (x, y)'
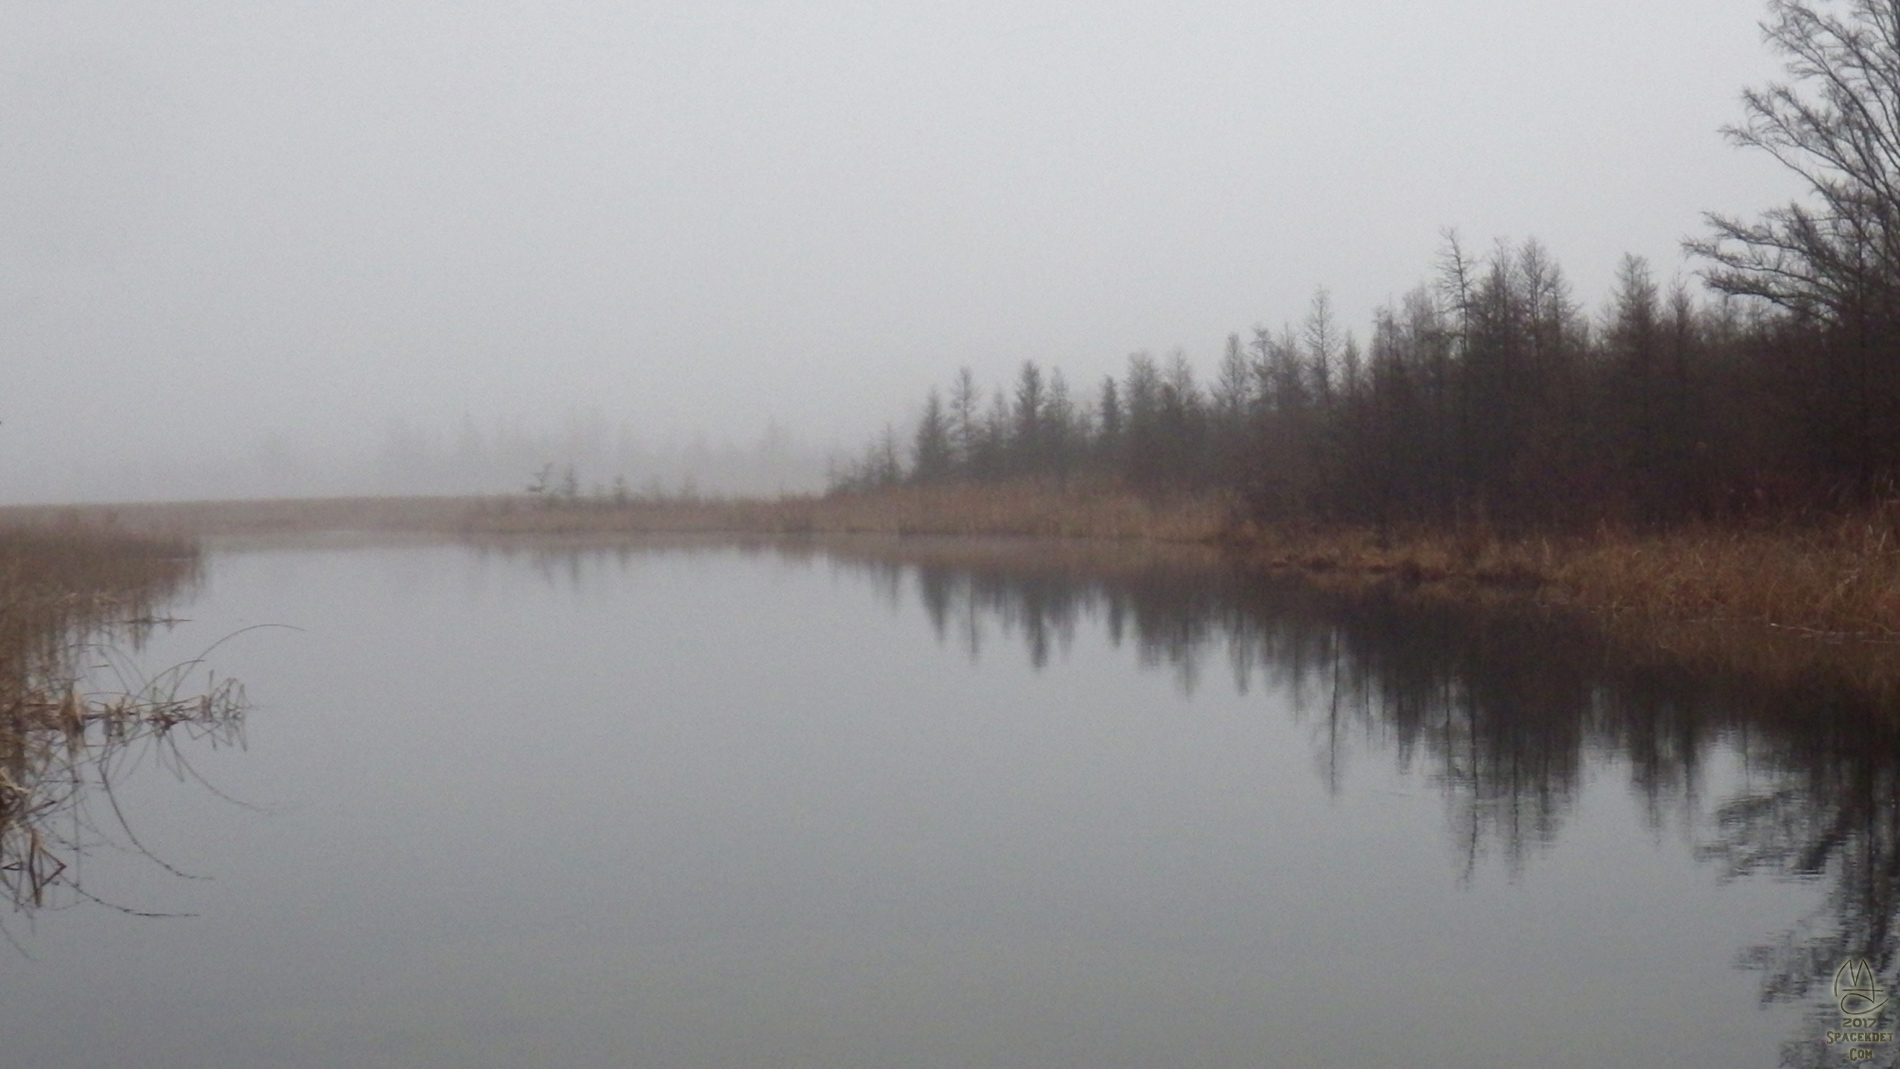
top-left (832, 239), bottom-right (1831, 522)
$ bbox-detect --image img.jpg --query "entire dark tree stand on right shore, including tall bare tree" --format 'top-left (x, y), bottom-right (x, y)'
top-left (834, 0), bottom-right (1900, 526)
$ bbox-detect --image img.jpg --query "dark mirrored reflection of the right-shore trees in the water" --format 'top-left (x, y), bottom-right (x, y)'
top-left (842, 553), bottom-right (1900, 1065)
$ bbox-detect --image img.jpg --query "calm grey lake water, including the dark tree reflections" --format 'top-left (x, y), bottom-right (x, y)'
top-left (0, 545), bottom-right (1900, 1069)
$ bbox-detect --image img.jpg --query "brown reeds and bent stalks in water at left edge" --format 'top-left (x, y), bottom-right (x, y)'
top-left (0, 526), bottom-right (245, 910)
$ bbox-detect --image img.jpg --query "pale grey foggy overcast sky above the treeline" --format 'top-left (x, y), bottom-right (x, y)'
top-left (0, 0), bottom-right (1796, 499)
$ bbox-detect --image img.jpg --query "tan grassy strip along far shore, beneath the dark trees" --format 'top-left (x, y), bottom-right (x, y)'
top-left (0, 484), bottom-right (1900, 644)
